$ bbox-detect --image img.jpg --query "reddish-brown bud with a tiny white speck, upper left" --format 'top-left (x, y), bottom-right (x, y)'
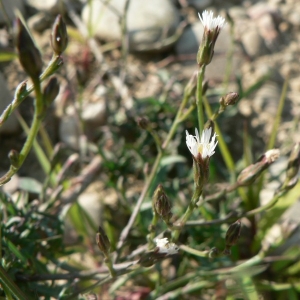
top-left (51, 15), bottom-right (68, 55)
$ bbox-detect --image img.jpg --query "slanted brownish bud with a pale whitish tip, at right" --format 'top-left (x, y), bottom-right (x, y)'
top-left (237, 149), bottom-right (280, 186)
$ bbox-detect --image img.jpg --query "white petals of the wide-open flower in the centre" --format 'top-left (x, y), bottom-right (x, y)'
top-left (186, 127), bottom-right (218, 159)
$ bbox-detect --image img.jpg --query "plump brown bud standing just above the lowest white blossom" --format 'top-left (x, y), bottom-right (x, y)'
top-left (153, 184), bottom-right (172, 220)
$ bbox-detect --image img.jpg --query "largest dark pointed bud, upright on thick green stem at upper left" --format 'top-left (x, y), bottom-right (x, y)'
top-left (15, 18), bottom-right (43, 80)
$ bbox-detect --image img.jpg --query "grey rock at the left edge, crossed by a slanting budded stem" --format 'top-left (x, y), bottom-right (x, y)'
top-left (0, 73), bottom-right (19, 134)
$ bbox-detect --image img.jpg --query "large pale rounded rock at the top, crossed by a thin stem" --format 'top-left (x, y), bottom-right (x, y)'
top-left (82, 0), bottom-right (179, 51)
